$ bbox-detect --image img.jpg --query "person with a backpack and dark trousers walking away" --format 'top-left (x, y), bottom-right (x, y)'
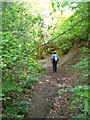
top-left (51, 51), bottom-right (59, 72)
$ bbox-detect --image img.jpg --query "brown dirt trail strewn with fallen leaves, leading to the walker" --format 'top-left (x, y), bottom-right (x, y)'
top-left (30, 50), bottom-right (80, 118)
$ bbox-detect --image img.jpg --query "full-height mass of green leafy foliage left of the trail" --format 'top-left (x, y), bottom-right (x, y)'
top-left (0, 2), bottom-right (45, 120)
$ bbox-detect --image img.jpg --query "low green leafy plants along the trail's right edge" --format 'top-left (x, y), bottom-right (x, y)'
top-left (58, 47), bottom-right (90, 119)
